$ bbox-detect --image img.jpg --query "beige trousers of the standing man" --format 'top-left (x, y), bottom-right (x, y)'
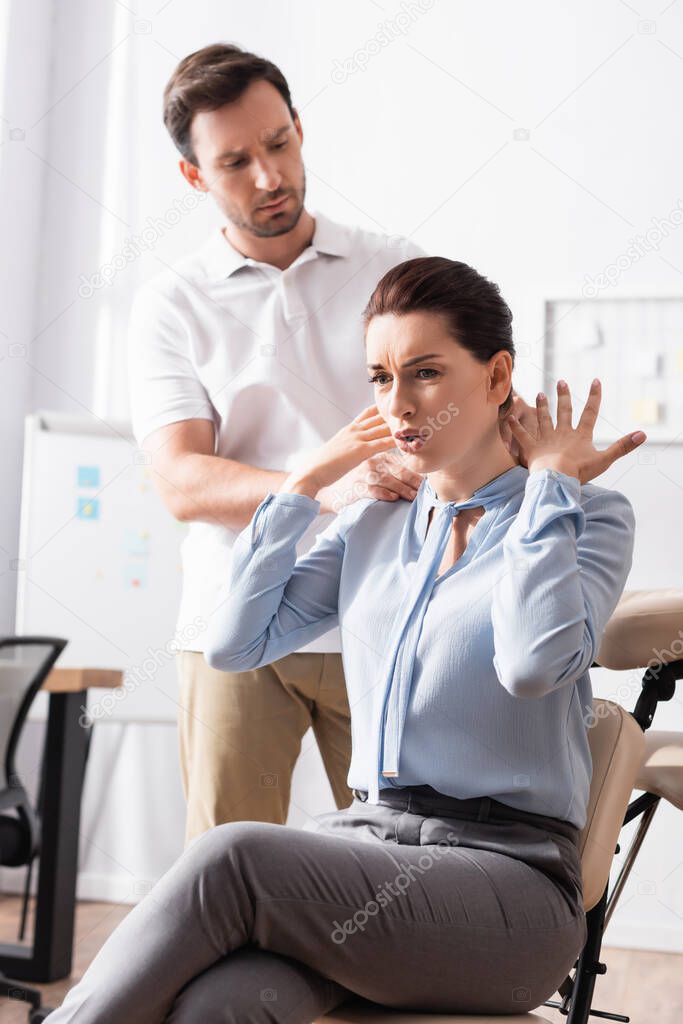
top-left (177, 650), bottom-right (353, 843)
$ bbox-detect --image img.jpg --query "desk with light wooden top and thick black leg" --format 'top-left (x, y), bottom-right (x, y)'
top-left (0, 669), bottom-right (123, 982)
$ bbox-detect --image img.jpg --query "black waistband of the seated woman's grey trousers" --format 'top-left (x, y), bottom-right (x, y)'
top-left (353, 785), bottom-right (580, 846)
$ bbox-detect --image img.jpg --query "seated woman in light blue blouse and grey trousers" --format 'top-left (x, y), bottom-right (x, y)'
top-left (50, 257), bottom-right (644, 1024)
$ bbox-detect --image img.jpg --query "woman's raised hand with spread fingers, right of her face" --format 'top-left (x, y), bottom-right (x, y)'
top-left (507, 378), bottom-right (646, 483)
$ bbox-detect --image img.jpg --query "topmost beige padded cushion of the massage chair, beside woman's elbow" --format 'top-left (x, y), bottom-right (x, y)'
top-left (595, 588), bottom-right (683, 670)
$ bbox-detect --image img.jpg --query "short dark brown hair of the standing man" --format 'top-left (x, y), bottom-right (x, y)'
top-left (164, 43), bottom-right (295, 167)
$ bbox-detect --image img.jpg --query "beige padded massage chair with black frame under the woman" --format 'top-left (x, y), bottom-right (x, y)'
top-left (316, 590), bottom-right (683, 1024)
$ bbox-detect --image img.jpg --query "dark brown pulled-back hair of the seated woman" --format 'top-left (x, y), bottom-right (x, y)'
top-left (362, 256), bottom-right (515, 415)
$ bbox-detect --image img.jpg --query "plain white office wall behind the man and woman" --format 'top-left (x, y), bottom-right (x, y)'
top-left (0, 0), bottom-right (683, 949)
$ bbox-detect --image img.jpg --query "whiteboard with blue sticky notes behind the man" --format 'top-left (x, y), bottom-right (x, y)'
top-left (16, 412), bottom-right (187, 722)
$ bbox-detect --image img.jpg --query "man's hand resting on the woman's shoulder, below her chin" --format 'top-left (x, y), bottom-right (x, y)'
top-left (317, 452), bottom-right (424, 513)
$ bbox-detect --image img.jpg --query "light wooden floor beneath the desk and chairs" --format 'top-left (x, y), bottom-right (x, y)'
top-left (0, 894), bottom-right (683, 1024)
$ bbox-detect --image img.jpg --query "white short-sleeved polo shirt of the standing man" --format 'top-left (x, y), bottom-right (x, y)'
top-left (128, 212), bottom-right (425, 651)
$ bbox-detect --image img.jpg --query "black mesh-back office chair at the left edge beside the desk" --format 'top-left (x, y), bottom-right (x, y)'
top-left (0, 636), bottom-right (68, 1020)
